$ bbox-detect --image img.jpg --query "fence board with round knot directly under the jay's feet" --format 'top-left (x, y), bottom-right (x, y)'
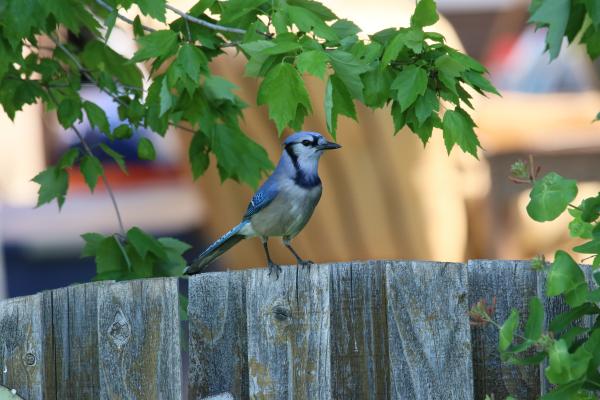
top-left (246, 266), bottom-right (331, 400)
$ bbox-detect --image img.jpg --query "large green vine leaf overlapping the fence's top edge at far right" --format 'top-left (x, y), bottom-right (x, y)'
top-left (546, 250), bottom-right (588, 307)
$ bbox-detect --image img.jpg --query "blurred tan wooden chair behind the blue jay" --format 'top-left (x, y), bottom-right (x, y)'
top-left (188, 0), bottom-right (488, 268)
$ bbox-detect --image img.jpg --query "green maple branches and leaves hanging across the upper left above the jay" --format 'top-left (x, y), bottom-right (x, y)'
top-left (0, 0), bottom-right (497, 279)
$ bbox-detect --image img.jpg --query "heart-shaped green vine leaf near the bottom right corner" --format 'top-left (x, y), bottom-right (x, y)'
top-left (545, 339), bottom-right (592, 384)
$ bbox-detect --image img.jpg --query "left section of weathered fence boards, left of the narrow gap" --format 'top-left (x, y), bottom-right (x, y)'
top-left (0, 279), bottom-right (181, 400)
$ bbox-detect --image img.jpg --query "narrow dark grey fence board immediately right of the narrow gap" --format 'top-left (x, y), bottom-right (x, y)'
top-left (188, 272), bottom-right (248, 399)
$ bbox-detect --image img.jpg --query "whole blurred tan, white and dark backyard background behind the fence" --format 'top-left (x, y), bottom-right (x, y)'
top-left (0, 0), bottom-right (600, 298)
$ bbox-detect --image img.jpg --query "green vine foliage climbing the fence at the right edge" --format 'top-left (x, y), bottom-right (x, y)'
top-left (499, 169), bottom-right (600, 400)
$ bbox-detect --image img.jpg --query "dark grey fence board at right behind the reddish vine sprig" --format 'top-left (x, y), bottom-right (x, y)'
top-left (468, 260), bottom-right (541, 400)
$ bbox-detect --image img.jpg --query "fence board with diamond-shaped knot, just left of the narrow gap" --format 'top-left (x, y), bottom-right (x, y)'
top-left (98, 278), bottom-right (181, 400)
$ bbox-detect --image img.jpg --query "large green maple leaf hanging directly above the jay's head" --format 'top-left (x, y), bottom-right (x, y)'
top-left (257, 63), bottom-right (312, 133)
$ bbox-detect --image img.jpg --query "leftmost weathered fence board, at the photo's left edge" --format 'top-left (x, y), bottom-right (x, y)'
top-left (0, 293), bottom-right (44, 400)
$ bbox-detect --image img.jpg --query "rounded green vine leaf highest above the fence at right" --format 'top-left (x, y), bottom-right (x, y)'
top-left (527, 172), bottom-right (577, 222)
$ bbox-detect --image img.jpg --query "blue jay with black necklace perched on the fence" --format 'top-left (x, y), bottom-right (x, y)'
top-left (184, 132), bottom-right (341, 277)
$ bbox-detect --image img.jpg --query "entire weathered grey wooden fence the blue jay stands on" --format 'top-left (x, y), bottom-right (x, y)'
top-left (0, 260), bottom-right (592, 400)
